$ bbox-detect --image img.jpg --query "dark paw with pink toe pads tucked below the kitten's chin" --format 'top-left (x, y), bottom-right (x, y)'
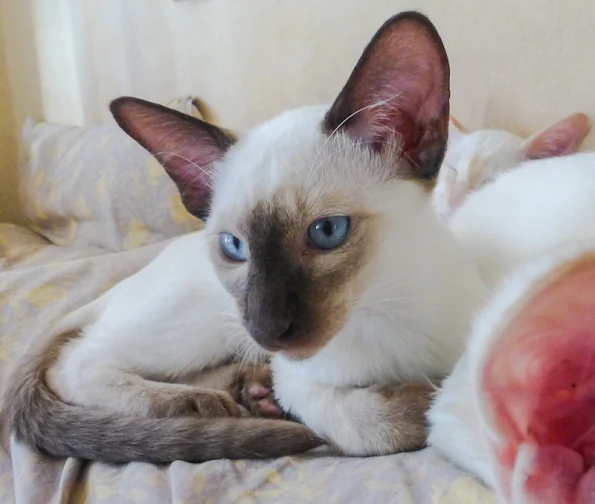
top-left (232, 364), bottom-right (284, 418)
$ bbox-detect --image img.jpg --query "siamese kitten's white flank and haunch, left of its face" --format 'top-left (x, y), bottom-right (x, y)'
top-left (51, 231), bottom-right (264, 414)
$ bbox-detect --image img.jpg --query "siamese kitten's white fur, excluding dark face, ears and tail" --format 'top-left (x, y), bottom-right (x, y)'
top-left (52, 107), bottom-right (486, 455)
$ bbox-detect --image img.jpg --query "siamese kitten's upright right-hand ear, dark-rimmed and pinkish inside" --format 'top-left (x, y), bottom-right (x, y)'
top-left (324, 12), bottom-right (450, 179)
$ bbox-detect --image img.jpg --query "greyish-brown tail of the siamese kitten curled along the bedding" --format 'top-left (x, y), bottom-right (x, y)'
top-left (2, 332), bottom-right (324, 463)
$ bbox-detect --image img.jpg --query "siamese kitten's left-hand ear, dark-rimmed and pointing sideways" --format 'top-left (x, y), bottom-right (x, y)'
top-left (110, 97), bottom-right (235, 219)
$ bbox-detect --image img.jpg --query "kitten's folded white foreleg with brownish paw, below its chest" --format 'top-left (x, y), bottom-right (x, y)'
top-left (274, 360), bottom-right (434, 456)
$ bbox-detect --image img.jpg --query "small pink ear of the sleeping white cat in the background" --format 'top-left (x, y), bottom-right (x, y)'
top-left (521, 113), bottom-right (591, 159)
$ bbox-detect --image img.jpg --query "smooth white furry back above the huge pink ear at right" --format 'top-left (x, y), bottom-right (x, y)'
top-left (450, 153), bottom-right (595, 285)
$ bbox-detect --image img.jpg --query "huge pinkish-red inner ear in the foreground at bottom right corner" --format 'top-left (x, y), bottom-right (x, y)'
top-left (481, 256), bottom-right (595, 504)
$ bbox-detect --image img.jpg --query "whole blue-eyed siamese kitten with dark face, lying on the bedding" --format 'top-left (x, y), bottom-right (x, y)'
top-left (5, 12), bottom-right (487, 462)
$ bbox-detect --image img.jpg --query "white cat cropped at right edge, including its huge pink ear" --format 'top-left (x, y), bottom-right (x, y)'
top-left (428, 146), bottom-right (595, 504)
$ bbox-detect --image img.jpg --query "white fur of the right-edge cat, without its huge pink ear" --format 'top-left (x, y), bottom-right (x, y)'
top-left (429, 154), bottom-right (595, 503)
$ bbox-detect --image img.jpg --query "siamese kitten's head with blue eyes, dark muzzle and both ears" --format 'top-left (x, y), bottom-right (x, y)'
top-left (112, 12), bottom-right (449, 359)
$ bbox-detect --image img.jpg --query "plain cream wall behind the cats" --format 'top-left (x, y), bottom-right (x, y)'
top-left (0, 0), bottom-right (595, 220)
